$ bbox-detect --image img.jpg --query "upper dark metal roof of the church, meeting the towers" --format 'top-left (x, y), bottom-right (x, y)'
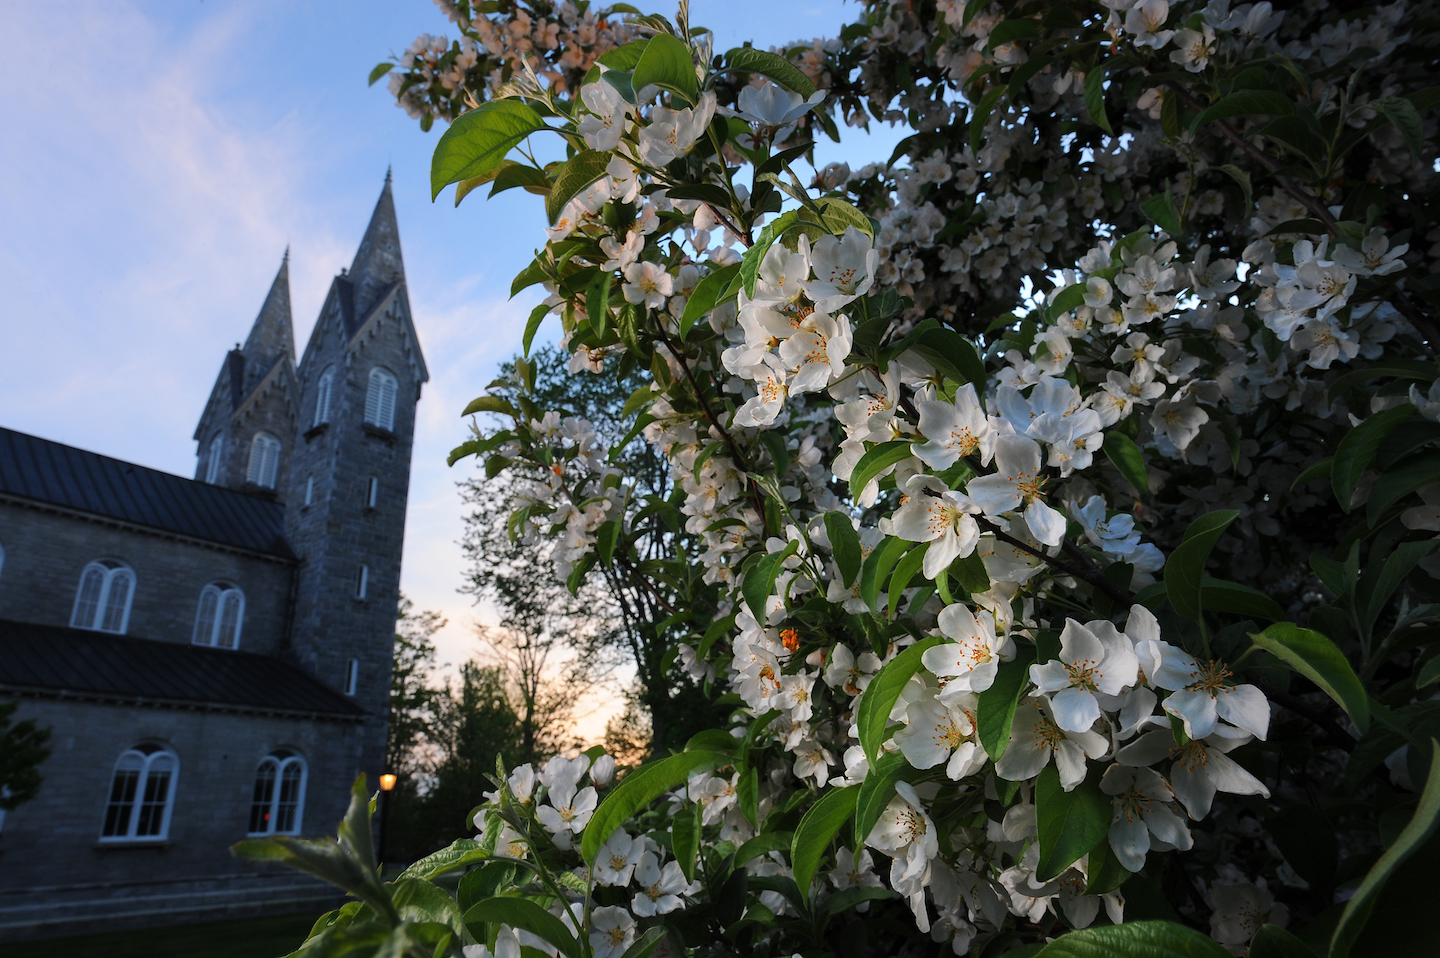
top-left (0, 426), bottom-right (295, 559)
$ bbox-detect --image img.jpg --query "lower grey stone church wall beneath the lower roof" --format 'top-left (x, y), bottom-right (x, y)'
top-left (0, 699), bottom-right (365, 941)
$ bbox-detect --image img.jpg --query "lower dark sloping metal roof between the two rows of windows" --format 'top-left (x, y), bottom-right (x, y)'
top-left (0, 619), bottom-right (366, 719)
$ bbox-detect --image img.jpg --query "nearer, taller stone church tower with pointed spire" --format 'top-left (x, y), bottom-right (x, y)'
top-left (282, 173), bottom-right (429, 781)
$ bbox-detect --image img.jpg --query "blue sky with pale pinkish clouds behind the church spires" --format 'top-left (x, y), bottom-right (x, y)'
top-left (0, 0), bottom-right (894, 728)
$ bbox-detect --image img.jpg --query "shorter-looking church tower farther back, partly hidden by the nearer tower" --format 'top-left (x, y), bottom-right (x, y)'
top-left (194, 249), bottom-right (298, 500)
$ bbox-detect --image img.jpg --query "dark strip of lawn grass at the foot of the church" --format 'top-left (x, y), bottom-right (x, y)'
top-left (0, 912), bottom-right (318, 958)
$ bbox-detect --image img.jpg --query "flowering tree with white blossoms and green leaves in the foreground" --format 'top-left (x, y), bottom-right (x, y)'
top-left (241, 0), bottom-right (1440, 958)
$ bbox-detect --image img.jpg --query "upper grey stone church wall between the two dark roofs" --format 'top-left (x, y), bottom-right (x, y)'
top-left (0, 500), bottom-right (294, 655)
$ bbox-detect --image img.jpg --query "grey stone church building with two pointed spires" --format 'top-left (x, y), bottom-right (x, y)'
top-left (0, 176), bottom-right (429, 941)
